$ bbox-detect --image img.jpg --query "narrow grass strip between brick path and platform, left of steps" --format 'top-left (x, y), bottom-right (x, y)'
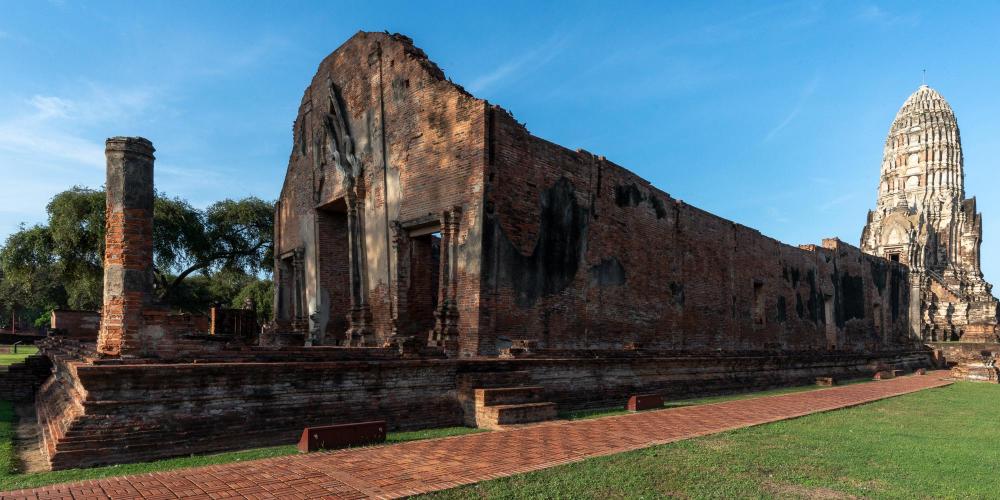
top-left (0, 412), bottom-right (484, 491)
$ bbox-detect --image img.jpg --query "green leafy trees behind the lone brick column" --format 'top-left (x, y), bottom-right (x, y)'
top-left (0, 187), bottom-right (274, 319)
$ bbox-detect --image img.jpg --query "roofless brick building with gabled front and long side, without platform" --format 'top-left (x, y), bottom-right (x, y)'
top-left (276, 33), bottom-right (909, 357)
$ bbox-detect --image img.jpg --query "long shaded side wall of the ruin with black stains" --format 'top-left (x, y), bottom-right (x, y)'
top-left (479, 108), bottom-right (908, 353)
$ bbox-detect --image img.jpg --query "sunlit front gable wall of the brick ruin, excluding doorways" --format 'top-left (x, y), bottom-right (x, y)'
top-left (275, 33), bottom-right (486, 345)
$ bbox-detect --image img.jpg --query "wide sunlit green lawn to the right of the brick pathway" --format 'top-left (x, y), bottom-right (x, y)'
top-left (430, 382), bottom-right (1000, 499)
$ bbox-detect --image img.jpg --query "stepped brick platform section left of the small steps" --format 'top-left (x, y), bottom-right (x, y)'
top-left (36, 338), bottom-right (462, 469)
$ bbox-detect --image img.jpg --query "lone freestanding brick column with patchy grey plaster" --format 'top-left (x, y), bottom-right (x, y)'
top-left (97, 137), bottom-right (154, 356)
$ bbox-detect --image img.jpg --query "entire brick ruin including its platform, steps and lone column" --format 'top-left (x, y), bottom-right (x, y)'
top-left (36, 32), bottom-right (931, 469)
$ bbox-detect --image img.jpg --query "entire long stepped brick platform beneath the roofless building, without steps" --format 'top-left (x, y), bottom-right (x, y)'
top-left (36, 341), bottom-right (930, 469)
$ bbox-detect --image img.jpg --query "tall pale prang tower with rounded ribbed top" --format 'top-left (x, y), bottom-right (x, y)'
top-left (861, 85), bottom-right (998, 341)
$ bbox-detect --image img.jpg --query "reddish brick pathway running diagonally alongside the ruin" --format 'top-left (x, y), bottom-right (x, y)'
top-left (2, 372), bottom-right (951, 499)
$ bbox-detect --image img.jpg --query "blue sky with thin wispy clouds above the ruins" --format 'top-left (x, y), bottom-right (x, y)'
top-left (0, 0), bottom-right (1000, 280)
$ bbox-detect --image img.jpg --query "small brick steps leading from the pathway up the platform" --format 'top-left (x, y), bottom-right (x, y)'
top-left (458, 371), bottom-right (556, 429)
